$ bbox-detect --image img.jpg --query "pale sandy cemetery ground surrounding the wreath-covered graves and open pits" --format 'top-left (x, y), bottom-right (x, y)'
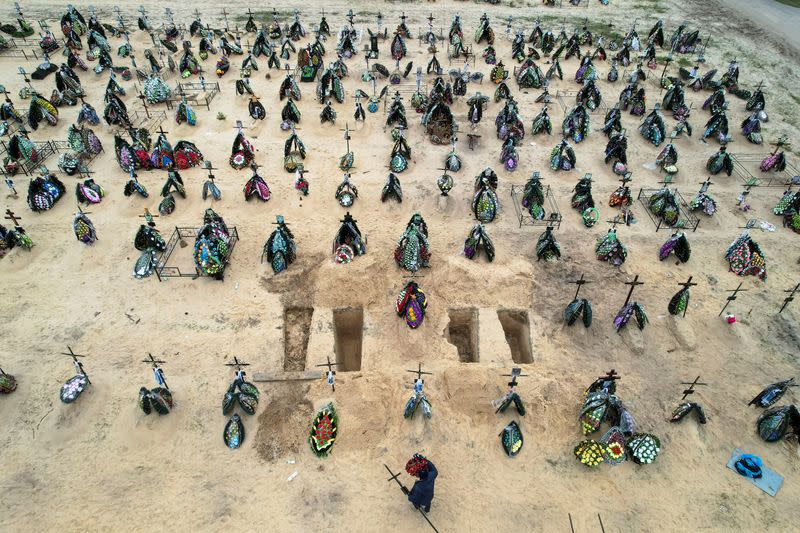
top-left (0, 0), bottom-right (800, 532)
